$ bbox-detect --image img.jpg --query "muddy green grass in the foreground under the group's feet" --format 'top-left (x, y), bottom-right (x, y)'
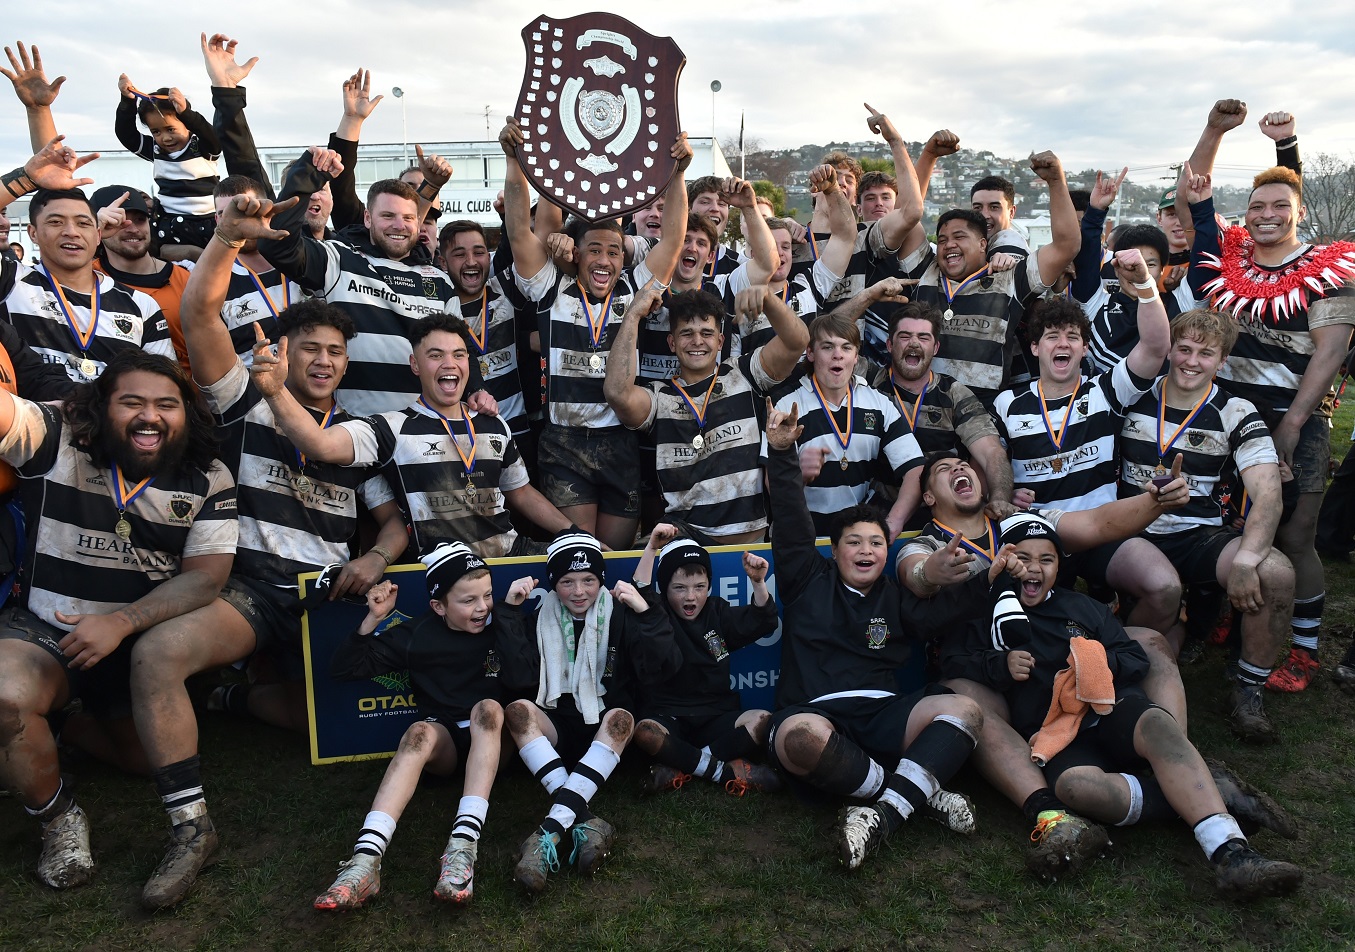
top-left (0, 405), bottom-right (1355, 952)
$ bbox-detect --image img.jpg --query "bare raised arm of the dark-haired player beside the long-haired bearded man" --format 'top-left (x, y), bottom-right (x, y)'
top-left (179, 195), bottom-right (297, 387)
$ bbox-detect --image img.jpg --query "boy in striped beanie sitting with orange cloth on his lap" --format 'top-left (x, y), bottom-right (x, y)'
top-left (970, 513), bottom-right (1304, 898)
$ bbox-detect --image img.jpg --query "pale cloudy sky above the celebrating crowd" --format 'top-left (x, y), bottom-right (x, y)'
top-left (0, 0), bottom-right (1355, 189)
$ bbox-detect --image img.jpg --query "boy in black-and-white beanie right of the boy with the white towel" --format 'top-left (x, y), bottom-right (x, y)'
top-left (633, 523), bottom-right (780, 796)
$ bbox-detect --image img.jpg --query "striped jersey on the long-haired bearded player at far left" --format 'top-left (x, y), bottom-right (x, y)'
top-left (0, 397), bottom-right (237, 631)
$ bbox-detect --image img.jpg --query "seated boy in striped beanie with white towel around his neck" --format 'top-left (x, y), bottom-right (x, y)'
top-left (504, 529), bottom-right (682, 892)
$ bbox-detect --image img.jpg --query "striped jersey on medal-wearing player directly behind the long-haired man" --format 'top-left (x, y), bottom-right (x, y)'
top-left (0, 259), bottom-right (178, 383)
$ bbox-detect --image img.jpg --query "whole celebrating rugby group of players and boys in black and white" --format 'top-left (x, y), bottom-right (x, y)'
top-left (0, 27), bottom-right (1338, 910)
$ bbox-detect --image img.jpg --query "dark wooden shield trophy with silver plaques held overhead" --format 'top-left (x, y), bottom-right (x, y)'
top-left (514, 14), bottom-right (687, 222)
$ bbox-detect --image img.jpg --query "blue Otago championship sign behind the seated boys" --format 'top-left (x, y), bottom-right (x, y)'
top-left (301, 544), bottom-right (924, 764)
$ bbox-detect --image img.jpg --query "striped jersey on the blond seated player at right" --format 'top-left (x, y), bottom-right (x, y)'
top-left (1119, 378), bottom-right (1279, 535)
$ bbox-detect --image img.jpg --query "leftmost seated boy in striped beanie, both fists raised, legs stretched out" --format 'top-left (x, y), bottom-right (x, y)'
top-left (314, 542), bottom-right (537, 909)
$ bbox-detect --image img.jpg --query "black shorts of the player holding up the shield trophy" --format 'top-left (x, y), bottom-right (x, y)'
top-left (538, 424), bottom-right (640, 519)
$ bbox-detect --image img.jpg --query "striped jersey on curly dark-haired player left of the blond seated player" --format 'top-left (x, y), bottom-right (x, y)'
top-left (993, 360), bottom-right (1153, 512)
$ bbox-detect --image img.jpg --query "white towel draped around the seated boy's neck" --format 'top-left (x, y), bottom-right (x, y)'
top-left (537, 589), bottom-right (612, 724)
